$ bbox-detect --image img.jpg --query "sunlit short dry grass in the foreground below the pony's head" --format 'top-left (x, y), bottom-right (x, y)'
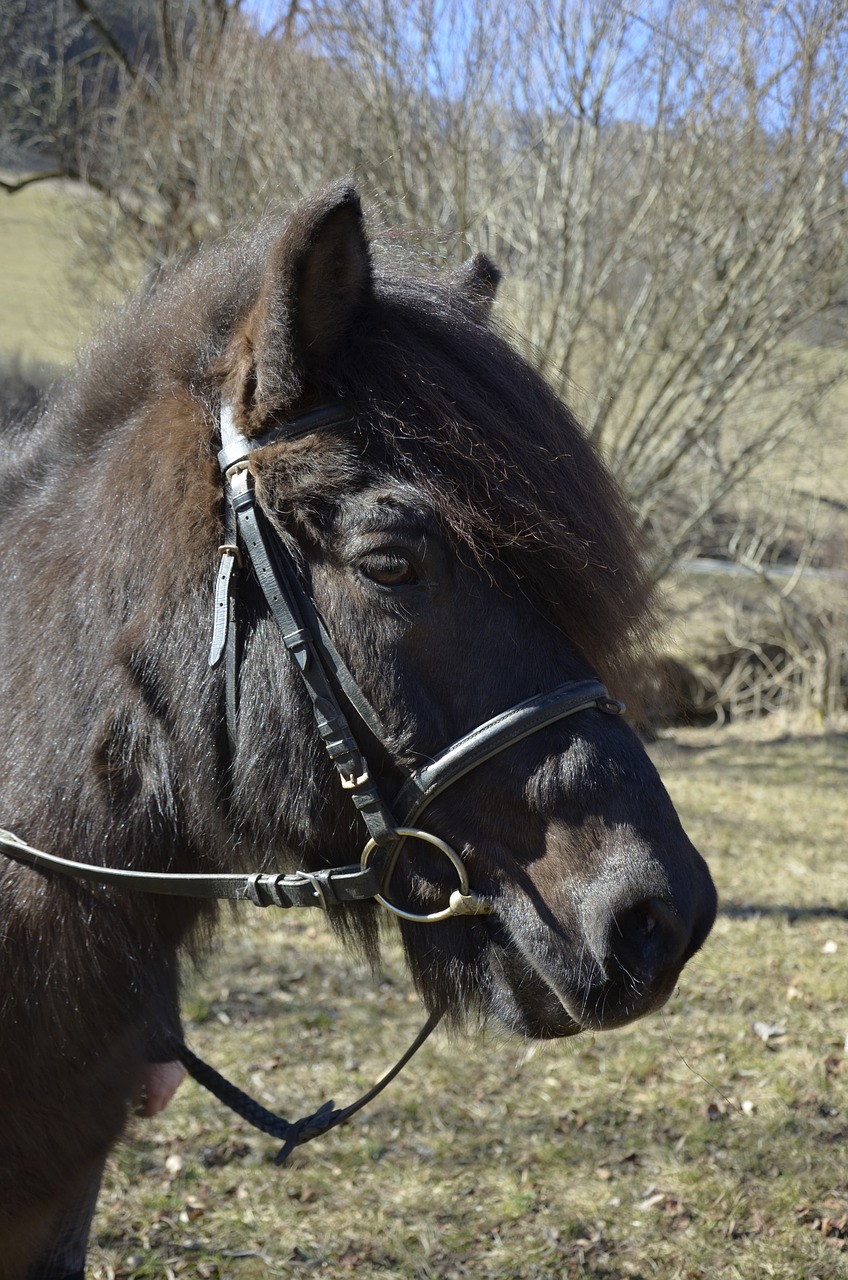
top-left (91, 731), bottom-right (848, 1280)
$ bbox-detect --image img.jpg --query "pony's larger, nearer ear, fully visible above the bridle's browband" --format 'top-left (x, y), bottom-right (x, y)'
top-left (225, 186), bottom-right (371, 430)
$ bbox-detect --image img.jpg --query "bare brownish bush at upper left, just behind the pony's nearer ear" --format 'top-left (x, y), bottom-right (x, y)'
top-left (68, 0), bottom-right (350, 265)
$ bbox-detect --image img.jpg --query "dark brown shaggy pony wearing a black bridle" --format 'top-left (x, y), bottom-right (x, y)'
top-left (0, 188), bottom-right (715, 1280)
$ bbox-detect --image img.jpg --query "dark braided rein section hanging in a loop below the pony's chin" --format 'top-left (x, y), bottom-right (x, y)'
top-left (167, 1009), bottom-right (444, 1165)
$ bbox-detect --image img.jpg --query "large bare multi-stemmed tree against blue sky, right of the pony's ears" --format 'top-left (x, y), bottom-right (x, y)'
top-left (302, 0), bottom-right (848, 575)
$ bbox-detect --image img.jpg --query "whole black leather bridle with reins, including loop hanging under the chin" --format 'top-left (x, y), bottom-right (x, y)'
top-left (0, 402), bottom-right (624, 1164)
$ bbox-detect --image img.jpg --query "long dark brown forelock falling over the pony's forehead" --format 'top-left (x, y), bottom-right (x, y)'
top-left (345, 277), bottom-right (653, 695)
